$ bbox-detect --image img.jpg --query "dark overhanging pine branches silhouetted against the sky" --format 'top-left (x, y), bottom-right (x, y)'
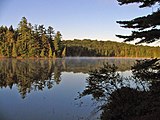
top-left (116, 0), bottom-right (160, 44)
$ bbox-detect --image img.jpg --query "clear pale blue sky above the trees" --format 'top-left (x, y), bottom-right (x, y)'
top-left (0, 0), bottom-right (152, 41)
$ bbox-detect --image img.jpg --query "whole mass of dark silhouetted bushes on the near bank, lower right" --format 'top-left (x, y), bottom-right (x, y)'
top-left (80, 59), bottom-right (160, 120)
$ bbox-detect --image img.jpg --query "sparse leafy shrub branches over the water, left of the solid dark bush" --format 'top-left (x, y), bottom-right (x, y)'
top-left (81, 63), bottom-right (121, 100)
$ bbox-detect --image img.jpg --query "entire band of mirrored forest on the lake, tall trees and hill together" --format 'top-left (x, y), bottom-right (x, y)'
top-left (0, 58), bottom-right (134, 98)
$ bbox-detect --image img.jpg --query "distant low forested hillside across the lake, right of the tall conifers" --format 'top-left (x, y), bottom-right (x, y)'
top-left (63, 39), bottom-right (160, 57)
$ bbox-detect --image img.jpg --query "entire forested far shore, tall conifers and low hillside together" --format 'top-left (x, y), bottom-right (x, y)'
top-left (0, 17), bottom-right (160, 58)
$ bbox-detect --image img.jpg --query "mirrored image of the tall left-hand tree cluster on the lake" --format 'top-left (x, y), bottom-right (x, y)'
top-left (0, 59), bottom-right (61, 98)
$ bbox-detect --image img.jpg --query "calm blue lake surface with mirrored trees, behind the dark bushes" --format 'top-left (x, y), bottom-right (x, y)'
top-left (0, 57), bottom-right (138, 120)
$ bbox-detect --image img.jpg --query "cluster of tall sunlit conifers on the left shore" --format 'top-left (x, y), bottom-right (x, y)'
top-left (0, 17), bottom-right (65, 57)
